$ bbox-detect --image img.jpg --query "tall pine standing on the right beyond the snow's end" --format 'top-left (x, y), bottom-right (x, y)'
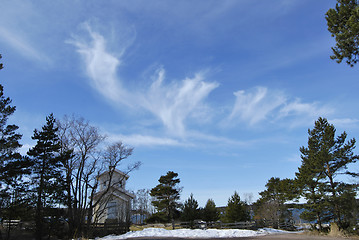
top-left (296, 118), bottom-right (358, 230)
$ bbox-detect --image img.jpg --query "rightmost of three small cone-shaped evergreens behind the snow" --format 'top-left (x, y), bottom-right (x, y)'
top-left (224, 192), bottom-right (249, 223)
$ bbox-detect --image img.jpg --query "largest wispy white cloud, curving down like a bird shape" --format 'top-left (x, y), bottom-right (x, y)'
top-left (68, 23), bottom-right (218, 135)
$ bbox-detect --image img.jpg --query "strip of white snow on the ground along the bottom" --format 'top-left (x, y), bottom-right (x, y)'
top-left (97, 228), bottom-right (288, 240)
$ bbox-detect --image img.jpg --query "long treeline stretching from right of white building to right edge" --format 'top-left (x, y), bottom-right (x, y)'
top-left (135, 118), bottom-right (359, 234)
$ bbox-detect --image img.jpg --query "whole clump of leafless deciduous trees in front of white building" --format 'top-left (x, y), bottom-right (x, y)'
top-left (58, 116), bottom-right (140, 238)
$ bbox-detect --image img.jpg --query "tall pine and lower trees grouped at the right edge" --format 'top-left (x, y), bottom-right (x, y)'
top-left (256, 118), bottom-right (359, 231)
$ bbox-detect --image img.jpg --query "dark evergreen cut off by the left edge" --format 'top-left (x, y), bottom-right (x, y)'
top-left (0, 55), bottom-right (28, 238)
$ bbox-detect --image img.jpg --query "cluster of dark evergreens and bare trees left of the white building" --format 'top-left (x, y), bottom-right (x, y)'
top-left (0, 55), bottom-right (140, 240)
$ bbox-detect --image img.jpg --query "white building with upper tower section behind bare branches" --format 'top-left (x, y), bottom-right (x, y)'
top-left (93, 169), bottom-right (135, 223)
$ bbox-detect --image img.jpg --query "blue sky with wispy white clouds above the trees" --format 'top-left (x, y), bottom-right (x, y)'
top-left (0, 0), bottom-right (359, 206)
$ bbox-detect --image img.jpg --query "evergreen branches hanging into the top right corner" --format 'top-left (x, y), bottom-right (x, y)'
top-left (325, 0), bottom-right (359, 66)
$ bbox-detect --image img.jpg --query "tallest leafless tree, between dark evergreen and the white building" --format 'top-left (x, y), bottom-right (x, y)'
top-left (57, 116), bottom-right (105, 238)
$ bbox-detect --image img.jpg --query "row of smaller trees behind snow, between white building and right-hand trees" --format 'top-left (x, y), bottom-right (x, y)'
top-left (133, 171), bottom-right (250, 226)
